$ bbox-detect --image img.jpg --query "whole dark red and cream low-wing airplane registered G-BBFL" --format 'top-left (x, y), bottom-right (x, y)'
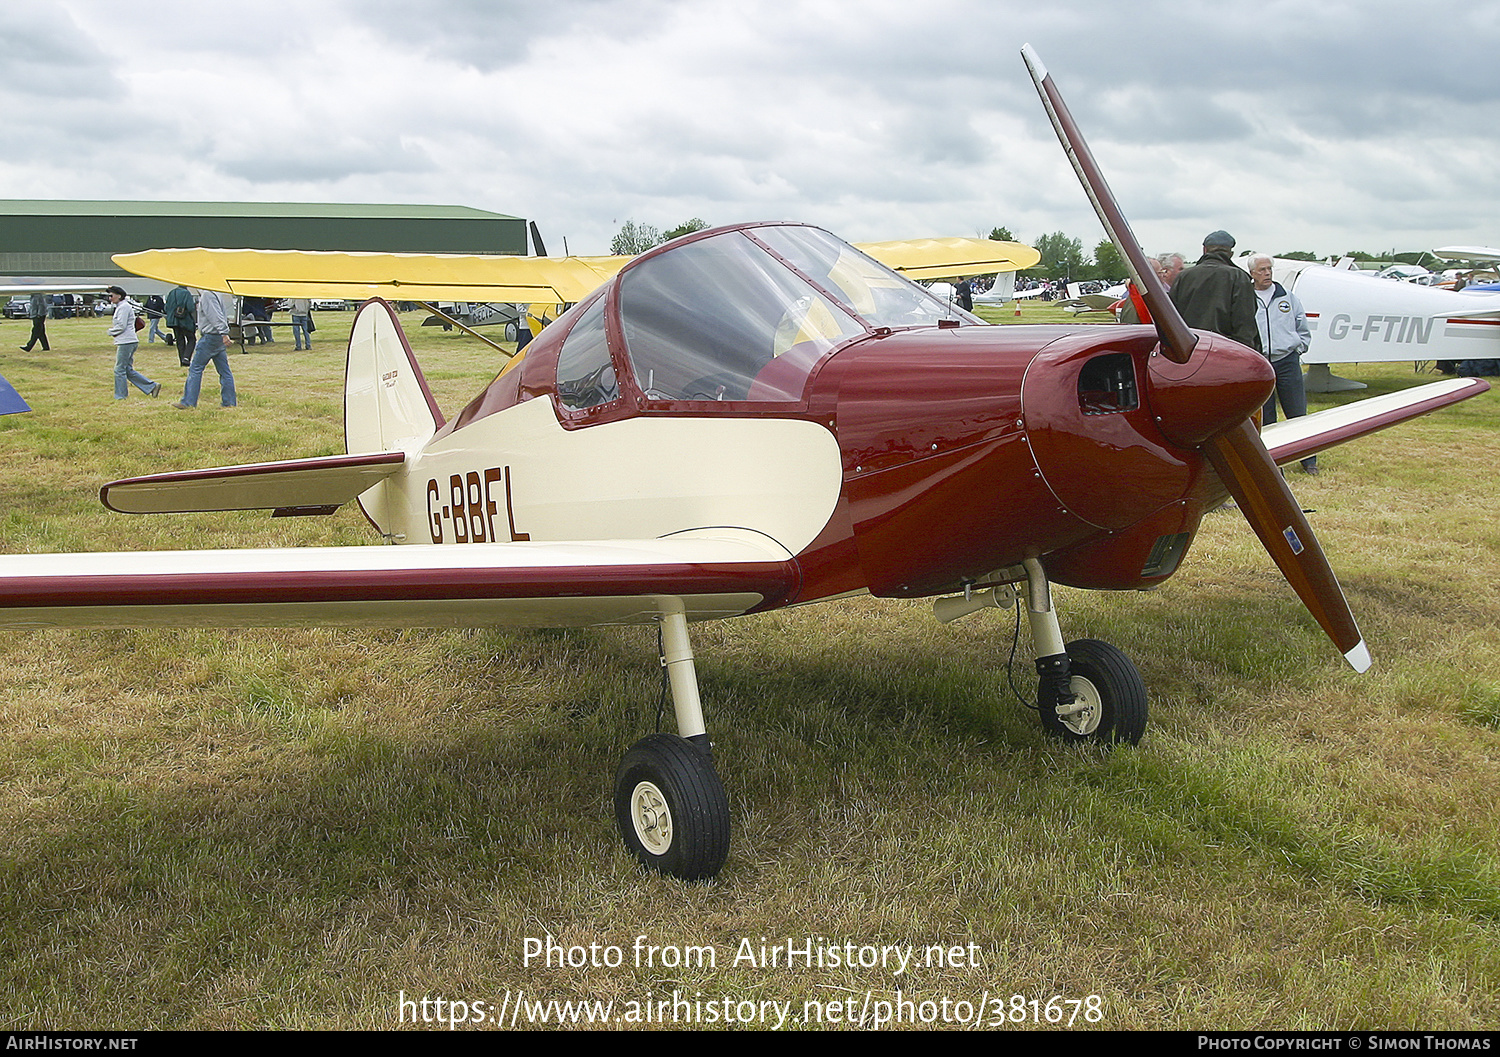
top-left (0, 49), bottom-right (1488, 879)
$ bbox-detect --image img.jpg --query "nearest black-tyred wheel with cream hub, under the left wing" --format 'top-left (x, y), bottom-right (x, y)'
top-left (615, 735), bottom-right (729, 880)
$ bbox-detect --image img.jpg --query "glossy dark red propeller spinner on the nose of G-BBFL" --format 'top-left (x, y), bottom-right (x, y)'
top-left (1148, 331), bottom-right (1277, 448)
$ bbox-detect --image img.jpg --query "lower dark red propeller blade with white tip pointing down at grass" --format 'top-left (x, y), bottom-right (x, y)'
top-left (1203, 421), bottom-right (1370, 672)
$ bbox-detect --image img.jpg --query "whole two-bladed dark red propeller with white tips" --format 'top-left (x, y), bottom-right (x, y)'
top-left (1022, 43), bottom-right (1370, 672)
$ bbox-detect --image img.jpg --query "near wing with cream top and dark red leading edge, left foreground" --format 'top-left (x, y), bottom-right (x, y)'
top-left (0, 529), bottom-right (801, 627)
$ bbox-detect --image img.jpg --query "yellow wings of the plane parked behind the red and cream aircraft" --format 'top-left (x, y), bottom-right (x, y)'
top-left (114, 238), bottom-right (1041, 304)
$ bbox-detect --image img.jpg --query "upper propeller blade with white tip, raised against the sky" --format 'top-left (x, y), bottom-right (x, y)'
top-left (1022, 43), bottom-right (1199, 363)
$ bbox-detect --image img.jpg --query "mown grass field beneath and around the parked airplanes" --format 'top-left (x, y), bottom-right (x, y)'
top-left (0, 306), bottom-right (1500, 1030)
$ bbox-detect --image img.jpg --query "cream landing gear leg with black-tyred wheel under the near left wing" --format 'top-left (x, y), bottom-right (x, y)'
top-left (615, 598), bottom-right (729, 880)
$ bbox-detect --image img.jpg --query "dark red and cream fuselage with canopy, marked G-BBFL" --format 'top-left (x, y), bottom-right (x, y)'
top-left (369, 218), bottom-right (1269, 601)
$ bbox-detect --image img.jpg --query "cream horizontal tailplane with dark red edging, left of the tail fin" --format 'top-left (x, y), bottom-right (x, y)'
top-left (99, 451), bottom-right (407, 514)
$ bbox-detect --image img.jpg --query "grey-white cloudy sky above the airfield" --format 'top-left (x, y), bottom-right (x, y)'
top-left (0, 0), bottom-right (1500, 253)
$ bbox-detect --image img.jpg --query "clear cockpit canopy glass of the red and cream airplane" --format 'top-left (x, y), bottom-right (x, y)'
top-left (558, 225), bottom-right (981, 409)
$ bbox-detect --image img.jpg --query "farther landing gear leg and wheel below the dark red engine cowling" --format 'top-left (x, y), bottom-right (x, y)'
top-left (933, 558), bottom-right (1146, 745)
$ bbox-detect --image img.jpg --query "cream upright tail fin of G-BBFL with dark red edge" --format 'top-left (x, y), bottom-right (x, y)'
top-left (344, 298), bottom-right (443, 532)
